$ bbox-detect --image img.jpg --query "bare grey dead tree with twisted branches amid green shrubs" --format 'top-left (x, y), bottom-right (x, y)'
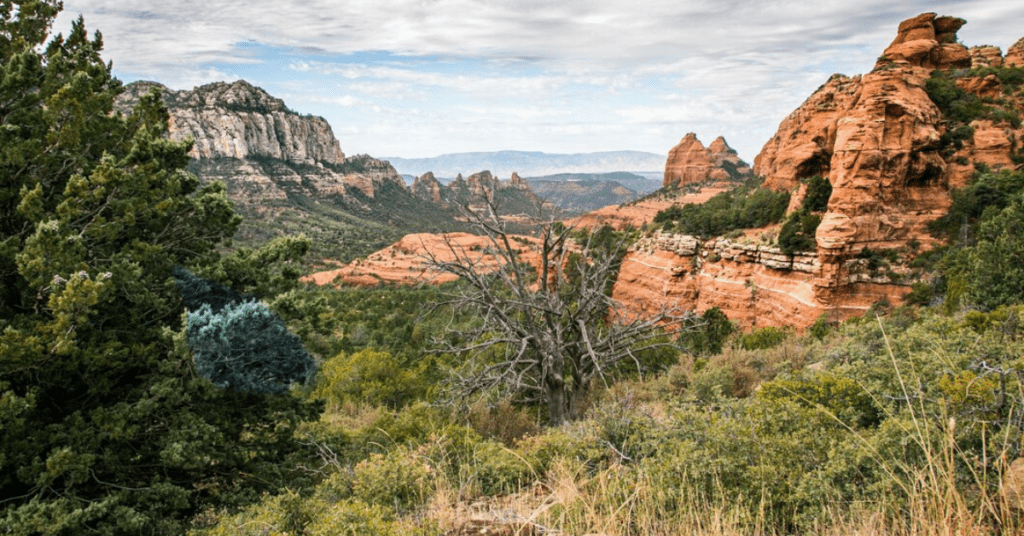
top-left (419, 194), bottom-right (692, 426)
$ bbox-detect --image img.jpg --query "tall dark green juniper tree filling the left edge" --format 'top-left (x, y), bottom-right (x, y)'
top-left (0, 0), bottom-right (321, 535)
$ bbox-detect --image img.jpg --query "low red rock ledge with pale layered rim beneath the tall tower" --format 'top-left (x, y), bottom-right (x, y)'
top-left (612, 232), bottom-right (905, 329)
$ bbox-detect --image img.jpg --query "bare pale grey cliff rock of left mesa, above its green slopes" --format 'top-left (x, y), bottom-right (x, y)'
top-left (118, 80), bottom-right (404, 205)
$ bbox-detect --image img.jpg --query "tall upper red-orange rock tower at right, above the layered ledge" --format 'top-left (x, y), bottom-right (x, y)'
top-left (754, 13), bottom-right (1010, 250)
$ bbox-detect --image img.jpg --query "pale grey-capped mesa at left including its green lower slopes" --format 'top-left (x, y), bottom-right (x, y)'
top-left (118, 81), bottom-right (465, 264)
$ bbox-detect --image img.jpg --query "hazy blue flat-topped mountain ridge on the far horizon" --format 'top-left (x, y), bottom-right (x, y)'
top-left (380, 151), bottom-right (665, 176)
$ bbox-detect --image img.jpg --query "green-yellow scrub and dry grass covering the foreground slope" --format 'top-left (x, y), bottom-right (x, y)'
top-left (194, 168), bottom-right (1024, 535)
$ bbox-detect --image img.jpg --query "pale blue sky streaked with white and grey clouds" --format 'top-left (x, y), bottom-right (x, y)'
top-left (54, 0), bottom-right (1024, 163)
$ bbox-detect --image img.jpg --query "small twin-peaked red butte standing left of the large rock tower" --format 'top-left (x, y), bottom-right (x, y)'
top-left (662, 132), bottom-right (750, 188)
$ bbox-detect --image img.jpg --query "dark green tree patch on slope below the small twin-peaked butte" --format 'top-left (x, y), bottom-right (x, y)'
top-left (654, 179), bottom-right (790, 238)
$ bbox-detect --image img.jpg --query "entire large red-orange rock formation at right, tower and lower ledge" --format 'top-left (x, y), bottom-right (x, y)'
top-left (614, 13), bottom-right (1024, 327)
